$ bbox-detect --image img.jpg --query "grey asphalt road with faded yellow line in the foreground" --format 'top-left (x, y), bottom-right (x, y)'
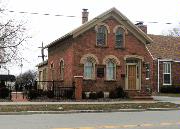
top-left (0, 110), bottom-right (180, 129)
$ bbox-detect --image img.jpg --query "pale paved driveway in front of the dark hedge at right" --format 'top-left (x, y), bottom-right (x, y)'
top-left (153, 96), bottom-right (180, 104)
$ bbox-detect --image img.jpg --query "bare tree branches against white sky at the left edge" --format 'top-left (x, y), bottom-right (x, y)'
top-left (0, 1), bottom-right (28, 63)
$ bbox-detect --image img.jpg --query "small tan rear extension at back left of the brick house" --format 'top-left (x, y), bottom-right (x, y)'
top-left (36, 60), bottom-right (48, 91)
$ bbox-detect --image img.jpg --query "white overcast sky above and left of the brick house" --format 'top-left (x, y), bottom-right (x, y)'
top-left (0, 0), bottom-right (180, 75)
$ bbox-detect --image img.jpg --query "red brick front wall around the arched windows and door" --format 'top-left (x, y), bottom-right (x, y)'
top-left (73, 19), bottom-right (153, 91)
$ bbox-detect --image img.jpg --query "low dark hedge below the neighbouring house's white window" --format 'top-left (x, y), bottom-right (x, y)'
top-left (160, 86), bottom-right (180, 93)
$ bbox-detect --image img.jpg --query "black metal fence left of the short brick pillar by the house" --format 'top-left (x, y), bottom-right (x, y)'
top-left (35, 81), bottom-right (75, 99)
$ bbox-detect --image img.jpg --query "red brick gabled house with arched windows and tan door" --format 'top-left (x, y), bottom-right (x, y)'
top-left (41, 8), bottom-right (156, 98)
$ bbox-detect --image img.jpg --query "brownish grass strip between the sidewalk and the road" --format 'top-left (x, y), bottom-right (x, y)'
top-left (0, 102), bottom-right (180, 112)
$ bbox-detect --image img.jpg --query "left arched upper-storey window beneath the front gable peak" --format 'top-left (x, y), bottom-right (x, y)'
top-left (96, 25), bottom-right (107, 46)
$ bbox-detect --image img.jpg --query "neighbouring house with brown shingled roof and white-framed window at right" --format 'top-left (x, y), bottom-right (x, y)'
top-left (148, 35), bottom-right (180, 91)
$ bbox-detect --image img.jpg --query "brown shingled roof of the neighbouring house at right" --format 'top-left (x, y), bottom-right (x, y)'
top-left (147, 35), bottom-right (180, 61)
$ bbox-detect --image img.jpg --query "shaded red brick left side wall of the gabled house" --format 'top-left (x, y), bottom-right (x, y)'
top-left (48, 39), bottom-right (74, 85)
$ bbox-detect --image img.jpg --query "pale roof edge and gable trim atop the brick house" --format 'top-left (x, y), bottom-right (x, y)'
top-left (46, 8), bottom-right (153, 48)
